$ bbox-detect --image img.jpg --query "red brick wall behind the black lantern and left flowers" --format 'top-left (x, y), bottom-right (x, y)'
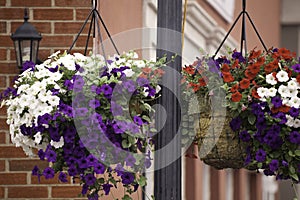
top-left (0, 0), bottom-right (91, 200)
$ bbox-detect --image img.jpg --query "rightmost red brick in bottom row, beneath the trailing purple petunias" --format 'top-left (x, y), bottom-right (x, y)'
top-left (52, 186), bottom-right (81, 198)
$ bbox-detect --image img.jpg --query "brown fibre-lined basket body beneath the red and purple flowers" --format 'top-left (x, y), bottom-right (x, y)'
top-left (191, 97), bottom-right (246, 169)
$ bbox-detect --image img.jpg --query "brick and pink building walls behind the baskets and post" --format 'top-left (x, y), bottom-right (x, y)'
top-left (0, 0), bottom-right (300, 200)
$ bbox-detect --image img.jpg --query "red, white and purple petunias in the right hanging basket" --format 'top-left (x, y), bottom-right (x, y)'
top-left (182, 48), bottom-right (300, 182)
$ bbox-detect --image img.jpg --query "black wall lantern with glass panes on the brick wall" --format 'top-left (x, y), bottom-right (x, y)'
top-left (11, 8), bottom-right (42, 68)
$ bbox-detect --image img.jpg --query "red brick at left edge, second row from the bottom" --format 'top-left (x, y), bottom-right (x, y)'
top-left (0, 173), bottom-right (27, 185)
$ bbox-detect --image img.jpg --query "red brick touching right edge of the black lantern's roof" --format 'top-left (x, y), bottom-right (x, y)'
top-left (40, 35), bottom-right (73, 47)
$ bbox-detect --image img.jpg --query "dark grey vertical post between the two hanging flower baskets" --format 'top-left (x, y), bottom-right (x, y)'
top-left (154, 0), bottom-right (182, 200)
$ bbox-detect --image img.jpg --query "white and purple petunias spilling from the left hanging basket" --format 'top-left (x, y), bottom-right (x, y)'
top-left (3, 52), bottom-right (165, 199)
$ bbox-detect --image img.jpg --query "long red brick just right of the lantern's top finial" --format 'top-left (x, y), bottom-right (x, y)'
top-left (33, 8), bottom-right (73, 20)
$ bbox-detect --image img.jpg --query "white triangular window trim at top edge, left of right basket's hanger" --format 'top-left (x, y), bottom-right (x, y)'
top-left (206, 0), bottom-right (235, 23)
